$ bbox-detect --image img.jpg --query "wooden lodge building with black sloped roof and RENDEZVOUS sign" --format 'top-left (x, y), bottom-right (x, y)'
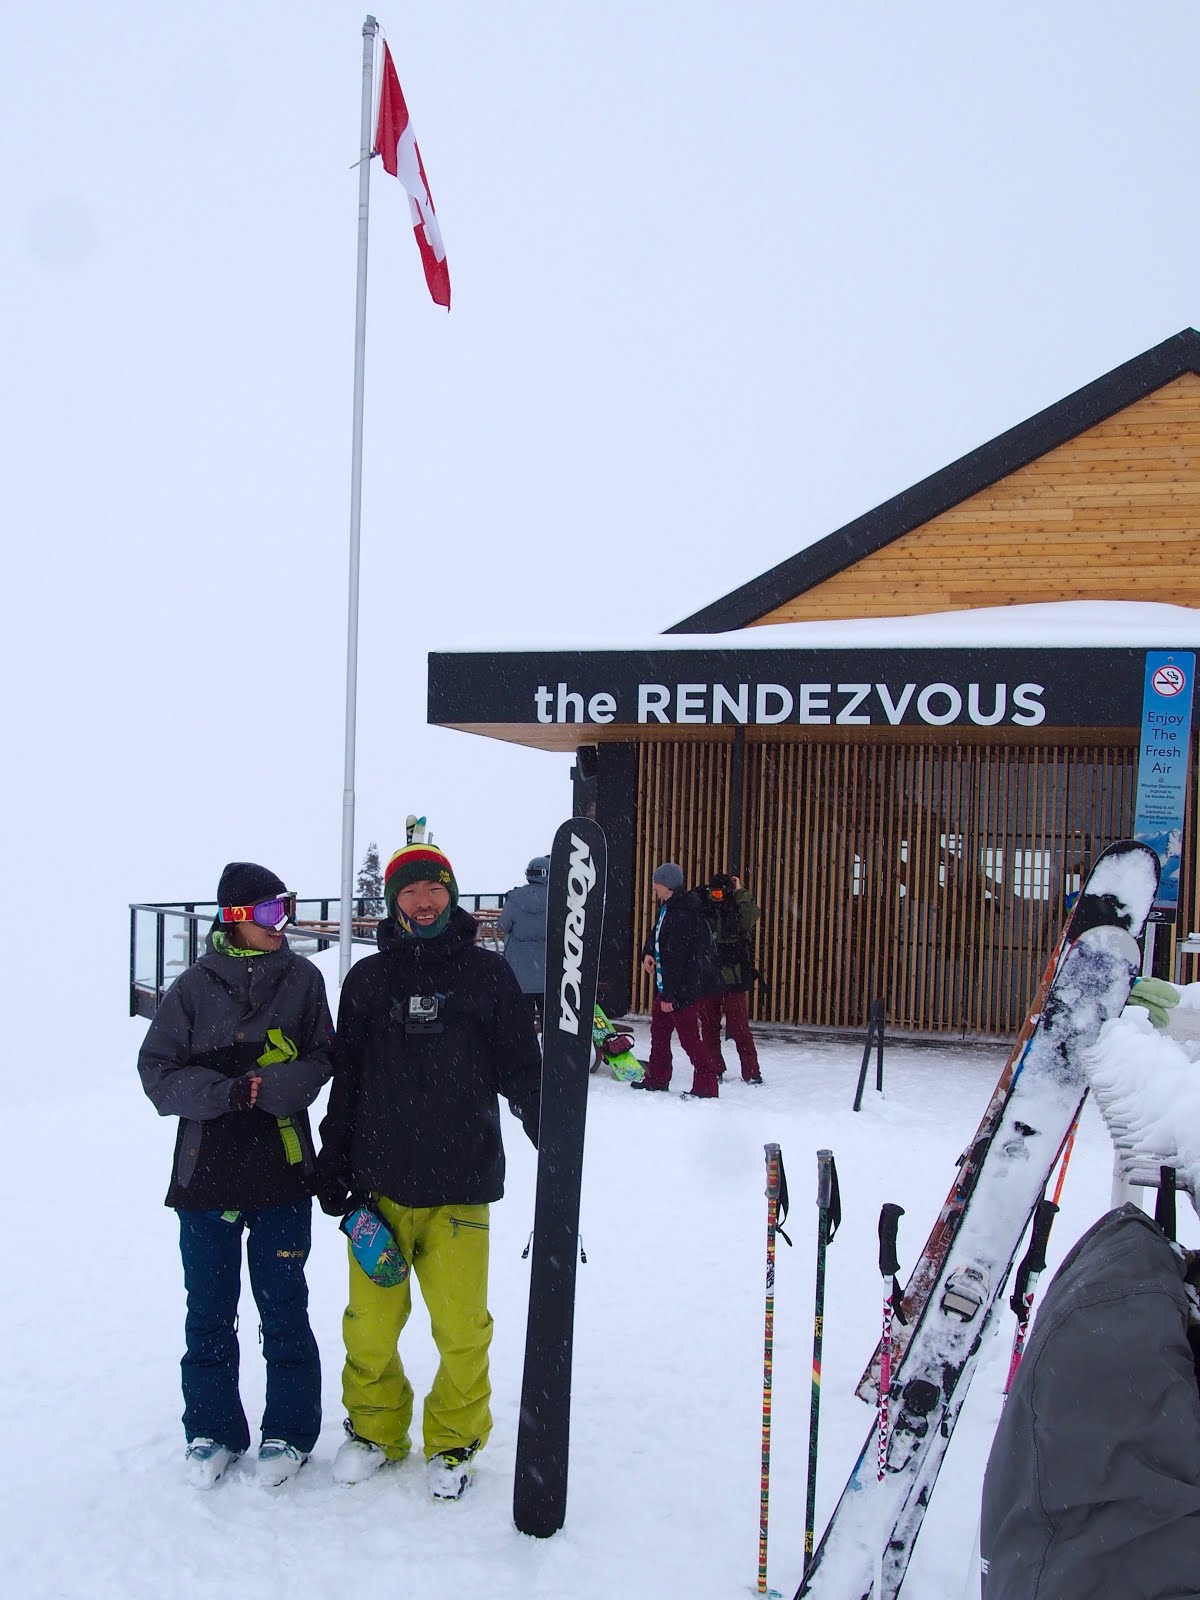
top-left (429, 328), bottom-right (1200, 1037)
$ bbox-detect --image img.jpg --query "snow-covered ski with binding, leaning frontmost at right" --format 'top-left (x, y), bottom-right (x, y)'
top-left (795, 845), bottom-right (1158, 1600)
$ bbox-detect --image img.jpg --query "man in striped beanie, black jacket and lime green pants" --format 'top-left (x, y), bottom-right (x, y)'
top-left (317, 843), bottom-right (541, 1499)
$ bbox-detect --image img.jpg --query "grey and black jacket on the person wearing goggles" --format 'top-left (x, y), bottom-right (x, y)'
top-left (138, 934), bottom-right (333, 1211)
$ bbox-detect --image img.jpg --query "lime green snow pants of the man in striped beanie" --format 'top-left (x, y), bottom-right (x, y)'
top-left (342, 1195), bottom-right (491, 1461)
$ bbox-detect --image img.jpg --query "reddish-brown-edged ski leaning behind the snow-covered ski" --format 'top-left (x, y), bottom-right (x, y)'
top-left (856, 838), bottom-right (1158, 1405)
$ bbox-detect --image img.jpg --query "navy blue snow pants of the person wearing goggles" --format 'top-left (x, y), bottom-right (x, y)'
top-left (178, 1200), bottom-right (322, 1451)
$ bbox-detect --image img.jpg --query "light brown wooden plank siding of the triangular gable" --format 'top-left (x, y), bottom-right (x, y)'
top-left (752, 373), bottom-right (1200, 626)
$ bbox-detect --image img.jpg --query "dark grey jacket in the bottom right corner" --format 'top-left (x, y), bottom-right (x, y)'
top-left (979, 1205), bottom-right (1200, 1600)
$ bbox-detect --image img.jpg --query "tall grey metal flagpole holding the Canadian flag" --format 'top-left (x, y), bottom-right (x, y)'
top-left (338, 16), bottom-right (379, 982)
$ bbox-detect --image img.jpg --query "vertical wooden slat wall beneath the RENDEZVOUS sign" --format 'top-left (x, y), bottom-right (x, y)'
top-left (634, 741), bottom-right (1139, 1037)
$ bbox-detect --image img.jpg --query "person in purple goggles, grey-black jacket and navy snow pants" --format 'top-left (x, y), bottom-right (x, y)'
top-left (138, 861), bottom-right (333, 1488)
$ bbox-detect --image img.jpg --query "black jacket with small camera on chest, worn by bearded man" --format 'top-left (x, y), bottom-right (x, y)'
top-left (318, 907), bottom-right (541, 1206)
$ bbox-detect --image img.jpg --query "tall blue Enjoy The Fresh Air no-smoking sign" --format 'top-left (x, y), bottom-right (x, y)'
top-left (1133, 650), bottom-right (1195, 922)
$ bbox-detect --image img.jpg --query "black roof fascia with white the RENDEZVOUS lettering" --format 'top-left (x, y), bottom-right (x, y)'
top-left (429, 645), bottom-right (1190, 732)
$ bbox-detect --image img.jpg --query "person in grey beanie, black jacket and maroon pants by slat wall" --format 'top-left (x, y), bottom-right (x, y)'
top-left (630, 861), bottom-right (720, 1099)
